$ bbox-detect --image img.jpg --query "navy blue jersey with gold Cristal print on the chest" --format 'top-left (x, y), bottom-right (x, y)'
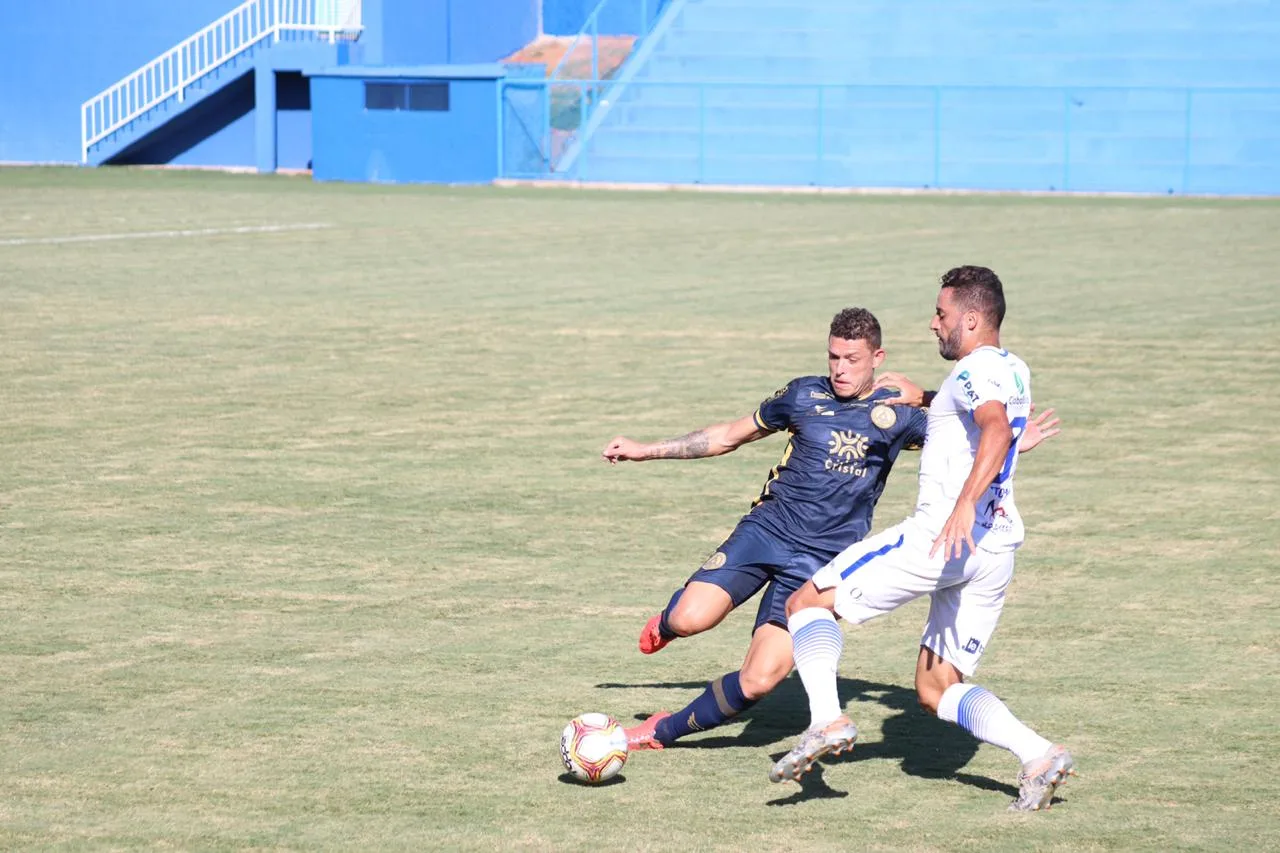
top-left (744, 377), bottom-right (928, 555)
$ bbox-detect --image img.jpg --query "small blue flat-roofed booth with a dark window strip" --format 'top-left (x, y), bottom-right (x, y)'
top-left (311, 64), bottom-right (506, 183)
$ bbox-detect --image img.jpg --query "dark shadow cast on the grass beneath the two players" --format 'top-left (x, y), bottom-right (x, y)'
top-left (596, 674), bottom-right (1018, 806)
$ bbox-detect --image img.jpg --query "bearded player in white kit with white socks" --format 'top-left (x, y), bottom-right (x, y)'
top-left (769, 266), bottom-right (1075, 811)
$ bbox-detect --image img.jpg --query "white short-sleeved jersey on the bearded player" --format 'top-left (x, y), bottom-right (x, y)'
top-left (913, 347), bottom-right (1032, 553)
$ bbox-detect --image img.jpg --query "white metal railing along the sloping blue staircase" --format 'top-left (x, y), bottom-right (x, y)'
top-left (81, 0), bottom-right (362, 163)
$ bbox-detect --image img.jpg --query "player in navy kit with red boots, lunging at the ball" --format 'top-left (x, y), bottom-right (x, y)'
top-left (602, 307), bottom-right (1057, 749)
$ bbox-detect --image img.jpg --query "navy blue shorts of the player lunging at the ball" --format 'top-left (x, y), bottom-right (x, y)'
top-left (685, 523), bottom-right (836, 630)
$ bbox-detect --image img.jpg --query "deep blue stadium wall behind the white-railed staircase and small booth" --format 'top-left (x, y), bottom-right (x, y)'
top-left (0, 0), bottom-right (540, 168)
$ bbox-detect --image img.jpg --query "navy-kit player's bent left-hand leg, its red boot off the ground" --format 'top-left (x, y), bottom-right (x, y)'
top-left (640, 524), bottom-right (781, 654)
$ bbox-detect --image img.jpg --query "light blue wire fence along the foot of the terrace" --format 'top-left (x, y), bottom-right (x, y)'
top-left (496, 79), bottom-right (1280, 195)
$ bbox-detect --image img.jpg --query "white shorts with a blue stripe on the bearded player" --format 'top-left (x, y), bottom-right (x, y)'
top-left (813, 519), bottom-right (1014, 675)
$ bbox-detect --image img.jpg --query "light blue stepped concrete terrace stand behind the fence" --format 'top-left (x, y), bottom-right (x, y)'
top-left (535, 0), bottom-right (1280, 193)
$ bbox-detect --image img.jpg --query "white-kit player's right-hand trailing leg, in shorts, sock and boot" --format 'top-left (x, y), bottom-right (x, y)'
top-left (915, 551), bottom-right (1075, 811)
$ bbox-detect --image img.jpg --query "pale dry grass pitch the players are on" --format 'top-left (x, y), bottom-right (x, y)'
top-left (0, 169), bottom-right (1280, 850)
